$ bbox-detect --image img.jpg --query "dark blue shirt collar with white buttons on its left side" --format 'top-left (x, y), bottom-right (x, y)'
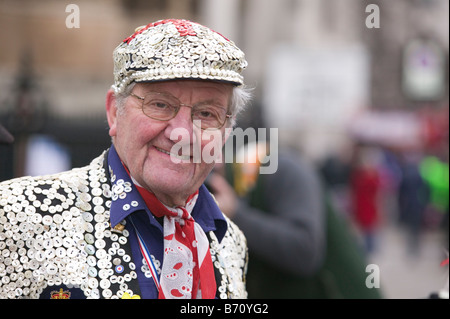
top-left (107, 145), bottom-right (228, 242)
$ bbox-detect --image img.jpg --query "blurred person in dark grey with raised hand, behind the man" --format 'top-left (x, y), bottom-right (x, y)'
top-left (208, 143), bottom-right (325, 298)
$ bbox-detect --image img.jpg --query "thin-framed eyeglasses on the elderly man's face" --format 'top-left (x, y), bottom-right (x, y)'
top-left (131, 92), bottom-right (232, 130)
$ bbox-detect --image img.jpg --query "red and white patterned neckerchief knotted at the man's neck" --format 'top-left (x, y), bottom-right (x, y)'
top-left (124, 165), bottom-right (216, 299)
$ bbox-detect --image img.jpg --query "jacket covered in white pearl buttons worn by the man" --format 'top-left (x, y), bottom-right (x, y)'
top-left (0, 152), bottom-right (247, 299)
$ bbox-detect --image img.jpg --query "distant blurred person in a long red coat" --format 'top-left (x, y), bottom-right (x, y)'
top-left (350, 145), bottom-right (381, 254)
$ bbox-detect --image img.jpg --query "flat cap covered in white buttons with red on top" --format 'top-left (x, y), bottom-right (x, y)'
top-left (113, 19), bottom-right (247, 93)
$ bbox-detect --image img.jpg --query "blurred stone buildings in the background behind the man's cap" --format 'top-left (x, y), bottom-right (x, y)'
top-left (0, 0), bottom-right (449, 180)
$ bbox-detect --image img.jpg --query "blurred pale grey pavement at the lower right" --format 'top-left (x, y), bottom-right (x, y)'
top-left (368, 224), bottom-right (449, 299)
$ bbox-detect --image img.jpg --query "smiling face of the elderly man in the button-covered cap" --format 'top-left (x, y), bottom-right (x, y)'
top-left (106, 80), bottom-right (233, 206)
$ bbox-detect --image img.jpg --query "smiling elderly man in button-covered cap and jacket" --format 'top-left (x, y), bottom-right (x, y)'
top-left (0, 20), bottom-right (249, 299)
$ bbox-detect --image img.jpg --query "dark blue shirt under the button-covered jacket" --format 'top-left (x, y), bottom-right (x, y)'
top-left (108, 146), bottom-right (227, 299)
